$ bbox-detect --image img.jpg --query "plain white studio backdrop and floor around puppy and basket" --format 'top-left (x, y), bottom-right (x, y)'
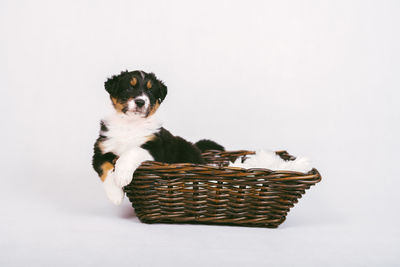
top-left (0, 0), bottom-right (400, 266)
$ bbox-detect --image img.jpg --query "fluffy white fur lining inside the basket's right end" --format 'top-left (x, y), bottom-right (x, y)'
top-left (229, 150), bottom-right (312, 173)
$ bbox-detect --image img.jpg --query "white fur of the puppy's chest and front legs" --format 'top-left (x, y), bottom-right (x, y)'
top-left (101, 113), bottom-right (161, 205)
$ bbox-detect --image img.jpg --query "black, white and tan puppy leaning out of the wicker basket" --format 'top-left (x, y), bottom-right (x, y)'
top-left (93, 71), bottom-right (224, 205)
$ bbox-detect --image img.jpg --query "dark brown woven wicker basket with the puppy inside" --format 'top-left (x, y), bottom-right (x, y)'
top-left (124, 150), bottom-right (321, 228)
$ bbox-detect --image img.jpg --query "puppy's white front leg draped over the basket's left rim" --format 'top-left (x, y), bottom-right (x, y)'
top-left (114, 147), bottom-right (153, 188)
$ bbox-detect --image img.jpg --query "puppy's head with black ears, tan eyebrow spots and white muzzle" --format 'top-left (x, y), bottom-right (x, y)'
top-left (104, 70), bottom-right (167, 117)
